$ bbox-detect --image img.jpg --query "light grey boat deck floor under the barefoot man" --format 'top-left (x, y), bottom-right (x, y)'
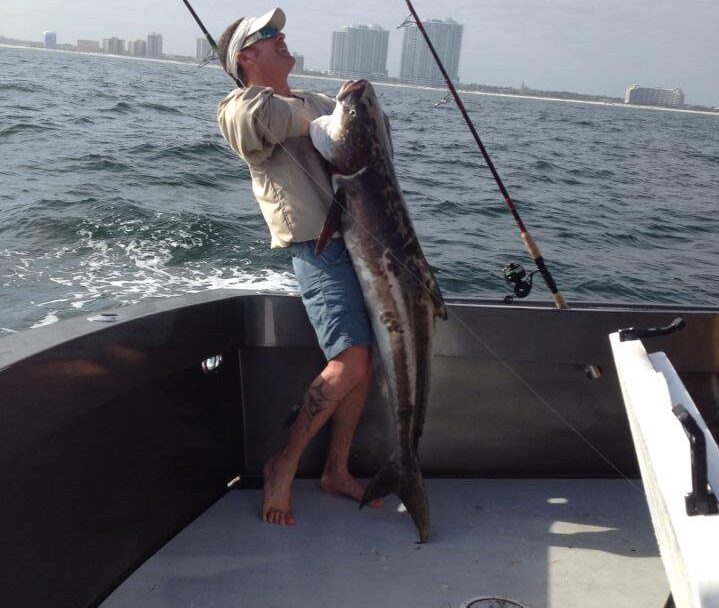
top-left (102, 479), bottom-right (669, 608)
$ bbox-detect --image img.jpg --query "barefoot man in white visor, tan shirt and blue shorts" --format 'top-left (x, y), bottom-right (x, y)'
top-left (218, 8), bottom-right (381, 526)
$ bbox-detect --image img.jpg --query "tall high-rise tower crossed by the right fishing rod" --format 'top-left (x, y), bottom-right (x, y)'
top-left (399, 19), bottom-right (463, 86)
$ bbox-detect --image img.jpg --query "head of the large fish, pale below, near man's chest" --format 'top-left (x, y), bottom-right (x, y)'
top-left (310, 80), bottom-right (391, 174)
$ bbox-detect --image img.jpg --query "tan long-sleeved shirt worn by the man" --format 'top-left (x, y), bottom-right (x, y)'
top-left (217, 86), bottom-right (335, 247)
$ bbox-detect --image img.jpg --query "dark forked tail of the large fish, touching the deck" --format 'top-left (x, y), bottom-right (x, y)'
top-left (360, 450), bottom-right (429, 543)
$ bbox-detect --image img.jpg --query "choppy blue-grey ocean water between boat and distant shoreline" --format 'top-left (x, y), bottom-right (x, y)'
top-left (0, 48), bottom-right (719, 336)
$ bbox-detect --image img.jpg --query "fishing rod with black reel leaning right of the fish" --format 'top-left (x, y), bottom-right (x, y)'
top-left (405, 0), bottom-right (569, 310)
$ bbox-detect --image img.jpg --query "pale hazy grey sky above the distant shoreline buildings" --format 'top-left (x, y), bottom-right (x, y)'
top-left (0, 0), bottom-right (719, 107)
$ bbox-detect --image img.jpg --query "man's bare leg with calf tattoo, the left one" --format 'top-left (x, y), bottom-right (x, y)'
top-left (262, 346), bottom-right (370, 526)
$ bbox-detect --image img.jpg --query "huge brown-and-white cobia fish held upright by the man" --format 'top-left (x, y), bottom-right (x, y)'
top-left (310, 80), bottom-right (447, 542)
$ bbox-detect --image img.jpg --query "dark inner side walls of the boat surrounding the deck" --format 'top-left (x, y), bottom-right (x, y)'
top-left (0, 291), bottom-right (719, 608)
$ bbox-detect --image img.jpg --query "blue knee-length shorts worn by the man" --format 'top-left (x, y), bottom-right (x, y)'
top-left (292, 239), bottom-right (372, 361)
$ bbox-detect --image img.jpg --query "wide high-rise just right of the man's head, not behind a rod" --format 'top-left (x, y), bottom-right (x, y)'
top-left (330, 25), bottom-right (389, 78)
